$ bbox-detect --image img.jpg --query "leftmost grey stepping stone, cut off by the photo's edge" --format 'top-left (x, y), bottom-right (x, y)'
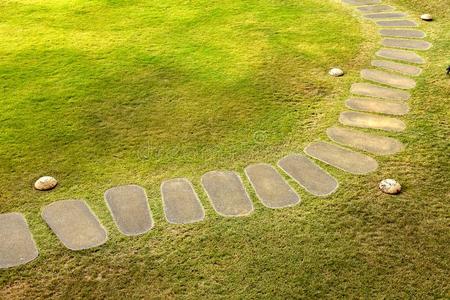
top-left (0, 213), bottom-right (38, 269)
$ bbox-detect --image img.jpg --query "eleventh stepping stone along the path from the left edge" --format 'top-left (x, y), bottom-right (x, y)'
top-left (345, 98), bottom-right (409, 116)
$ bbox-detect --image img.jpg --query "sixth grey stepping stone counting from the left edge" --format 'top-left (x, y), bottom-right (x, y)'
top-left (245, 164), bottom-right (300, 208)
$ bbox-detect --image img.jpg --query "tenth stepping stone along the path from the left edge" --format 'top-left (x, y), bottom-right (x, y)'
top-left (339, 111), bottom-right (406, 131)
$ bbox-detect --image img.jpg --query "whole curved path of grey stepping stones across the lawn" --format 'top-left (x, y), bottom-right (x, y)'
top-left (0, 0), bottom-right (432, 268)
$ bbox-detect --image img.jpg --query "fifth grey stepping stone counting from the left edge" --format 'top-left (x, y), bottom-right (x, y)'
top-left (202, 171), bottom-right (253, 217)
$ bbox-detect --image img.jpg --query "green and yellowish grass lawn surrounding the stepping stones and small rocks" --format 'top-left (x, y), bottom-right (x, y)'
top-left (0, 0), bottom-right (450, 299)
